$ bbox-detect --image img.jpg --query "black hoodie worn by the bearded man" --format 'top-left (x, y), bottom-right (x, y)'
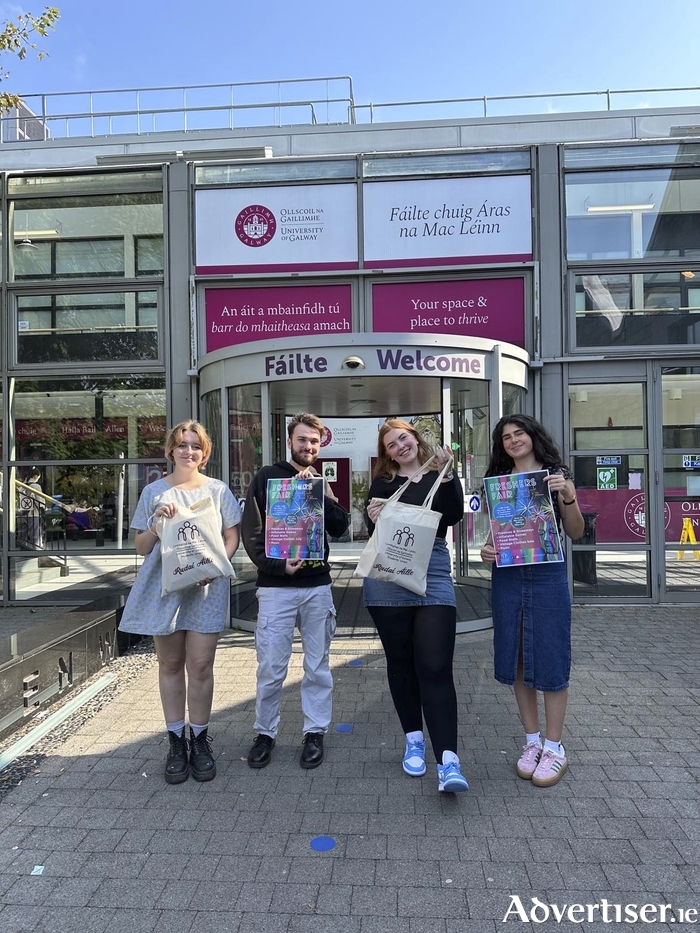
top-left (242, 460), bottom-right (350, 586)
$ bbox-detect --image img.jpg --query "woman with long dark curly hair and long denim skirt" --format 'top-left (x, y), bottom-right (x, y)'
top-left (481, 415), bottom-right (584, 787)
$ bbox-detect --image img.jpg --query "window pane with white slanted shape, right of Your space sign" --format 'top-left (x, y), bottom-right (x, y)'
top-left (575, 270), bottom-right (700, 347)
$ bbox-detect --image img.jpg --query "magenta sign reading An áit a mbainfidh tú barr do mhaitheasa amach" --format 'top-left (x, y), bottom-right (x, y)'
top-left (204, 285), bottom-right (352, 353)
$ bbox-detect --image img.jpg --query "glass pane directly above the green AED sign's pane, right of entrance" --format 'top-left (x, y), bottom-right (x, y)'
top-left (569, 382), bottom-right (647, 455)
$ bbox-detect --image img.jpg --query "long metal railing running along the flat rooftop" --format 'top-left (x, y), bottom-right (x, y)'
top-left (0, 75), bottom-right (700, 143)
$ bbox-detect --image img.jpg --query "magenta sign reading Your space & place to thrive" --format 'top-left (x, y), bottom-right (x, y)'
top-left (372, 278), bottom-right (525, 347)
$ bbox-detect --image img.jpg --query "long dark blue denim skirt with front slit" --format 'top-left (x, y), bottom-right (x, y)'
top-left (491, 562), bottom-right (571, 693)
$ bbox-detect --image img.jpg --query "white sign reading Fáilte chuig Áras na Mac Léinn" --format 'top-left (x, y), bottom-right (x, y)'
top-left (363, 175), bottom-right (532, 268)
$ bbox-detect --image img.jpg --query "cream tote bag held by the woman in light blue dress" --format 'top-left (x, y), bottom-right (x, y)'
top-left (158, 496), bottom-right (235, 596)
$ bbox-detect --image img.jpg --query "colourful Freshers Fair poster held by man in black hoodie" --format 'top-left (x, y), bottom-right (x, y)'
top-left (265, 477), bottom-right (324, 560)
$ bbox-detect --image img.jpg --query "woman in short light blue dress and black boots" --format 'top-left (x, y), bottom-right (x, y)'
top-left (119, 421), bottom-right (241, 784)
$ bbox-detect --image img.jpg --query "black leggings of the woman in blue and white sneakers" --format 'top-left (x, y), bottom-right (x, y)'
top-left (367, 606), bottom-right (457, 764)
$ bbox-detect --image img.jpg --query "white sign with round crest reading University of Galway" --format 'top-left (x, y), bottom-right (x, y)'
top-left (195, 185), bottom-right (358, 274)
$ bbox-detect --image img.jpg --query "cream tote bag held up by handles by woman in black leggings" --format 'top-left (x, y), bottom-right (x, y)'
top-left (355, 457), bottom-right (452, 596)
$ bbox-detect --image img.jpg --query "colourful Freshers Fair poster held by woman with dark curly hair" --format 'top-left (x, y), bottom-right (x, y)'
top-left (484, 470), bottom-right (564, 567)
